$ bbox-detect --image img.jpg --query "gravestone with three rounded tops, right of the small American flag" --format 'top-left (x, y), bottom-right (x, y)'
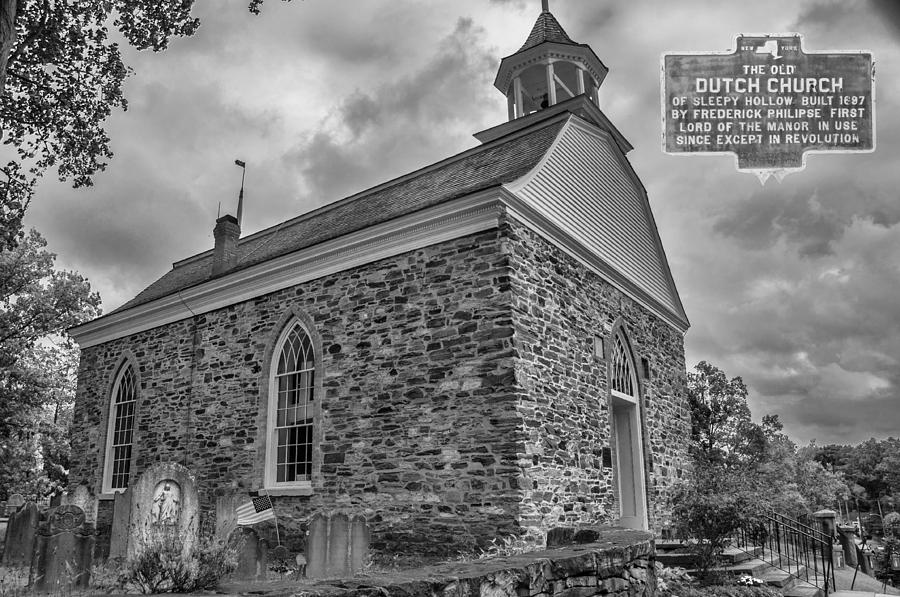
top-left (306, 513), bottom-right (369, 578)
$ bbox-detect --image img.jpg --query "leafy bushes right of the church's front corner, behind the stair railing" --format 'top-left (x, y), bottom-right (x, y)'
top-left (671, 362), bottom-right (847, 574)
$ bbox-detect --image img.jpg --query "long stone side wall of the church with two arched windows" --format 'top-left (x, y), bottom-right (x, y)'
top-left (70, 230), bottom-right (525, 554)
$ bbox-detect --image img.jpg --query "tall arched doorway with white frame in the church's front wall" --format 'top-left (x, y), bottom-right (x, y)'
top-left (609, 330), bottom-right (648, 529)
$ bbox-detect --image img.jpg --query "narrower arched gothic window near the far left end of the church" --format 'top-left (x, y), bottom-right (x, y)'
top-left (103, 363), bottom-right (137, 493)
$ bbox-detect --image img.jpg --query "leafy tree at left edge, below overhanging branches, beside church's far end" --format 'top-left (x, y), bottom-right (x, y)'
top-left (0, 231), bottom-right (100, 497)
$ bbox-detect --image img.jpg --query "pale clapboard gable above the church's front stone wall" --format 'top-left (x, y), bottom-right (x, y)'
top-left (505, 116), bottom-right (689, 330)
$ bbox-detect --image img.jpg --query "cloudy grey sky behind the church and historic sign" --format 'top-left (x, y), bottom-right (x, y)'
top-left (12, 0), bottom-right (900, 444)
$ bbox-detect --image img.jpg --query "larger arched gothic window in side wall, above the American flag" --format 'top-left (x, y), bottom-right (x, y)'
top-left (266, 321), bottom-right (316, 487)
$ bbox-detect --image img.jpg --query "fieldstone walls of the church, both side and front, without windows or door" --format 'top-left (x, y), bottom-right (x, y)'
top-left (70, 212), bottom-right (689, 556)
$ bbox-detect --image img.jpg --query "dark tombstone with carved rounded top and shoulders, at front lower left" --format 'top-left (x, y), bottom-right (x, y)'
top-left (31, 505), bottom-right (95, 593)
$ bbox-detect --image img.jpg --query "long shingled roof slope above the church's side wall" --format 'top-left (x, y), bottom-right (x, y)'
top-left (113, 120), bottom-right (564, 313)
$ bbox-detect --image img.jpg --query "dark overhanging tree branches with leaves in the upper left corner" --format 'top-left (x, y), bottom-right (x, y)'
top-left (0, 0), bottom-right (290, 250)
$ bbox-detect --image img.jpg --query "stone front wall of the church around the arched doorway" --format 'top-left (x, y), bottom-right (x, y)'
top-left (504, 218), bottom-right (690, 535)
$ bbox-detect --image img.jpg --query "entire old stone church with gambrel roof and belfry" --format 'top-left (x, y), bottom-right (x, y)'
top-left (70, 2), bottom-right (690, 554)
